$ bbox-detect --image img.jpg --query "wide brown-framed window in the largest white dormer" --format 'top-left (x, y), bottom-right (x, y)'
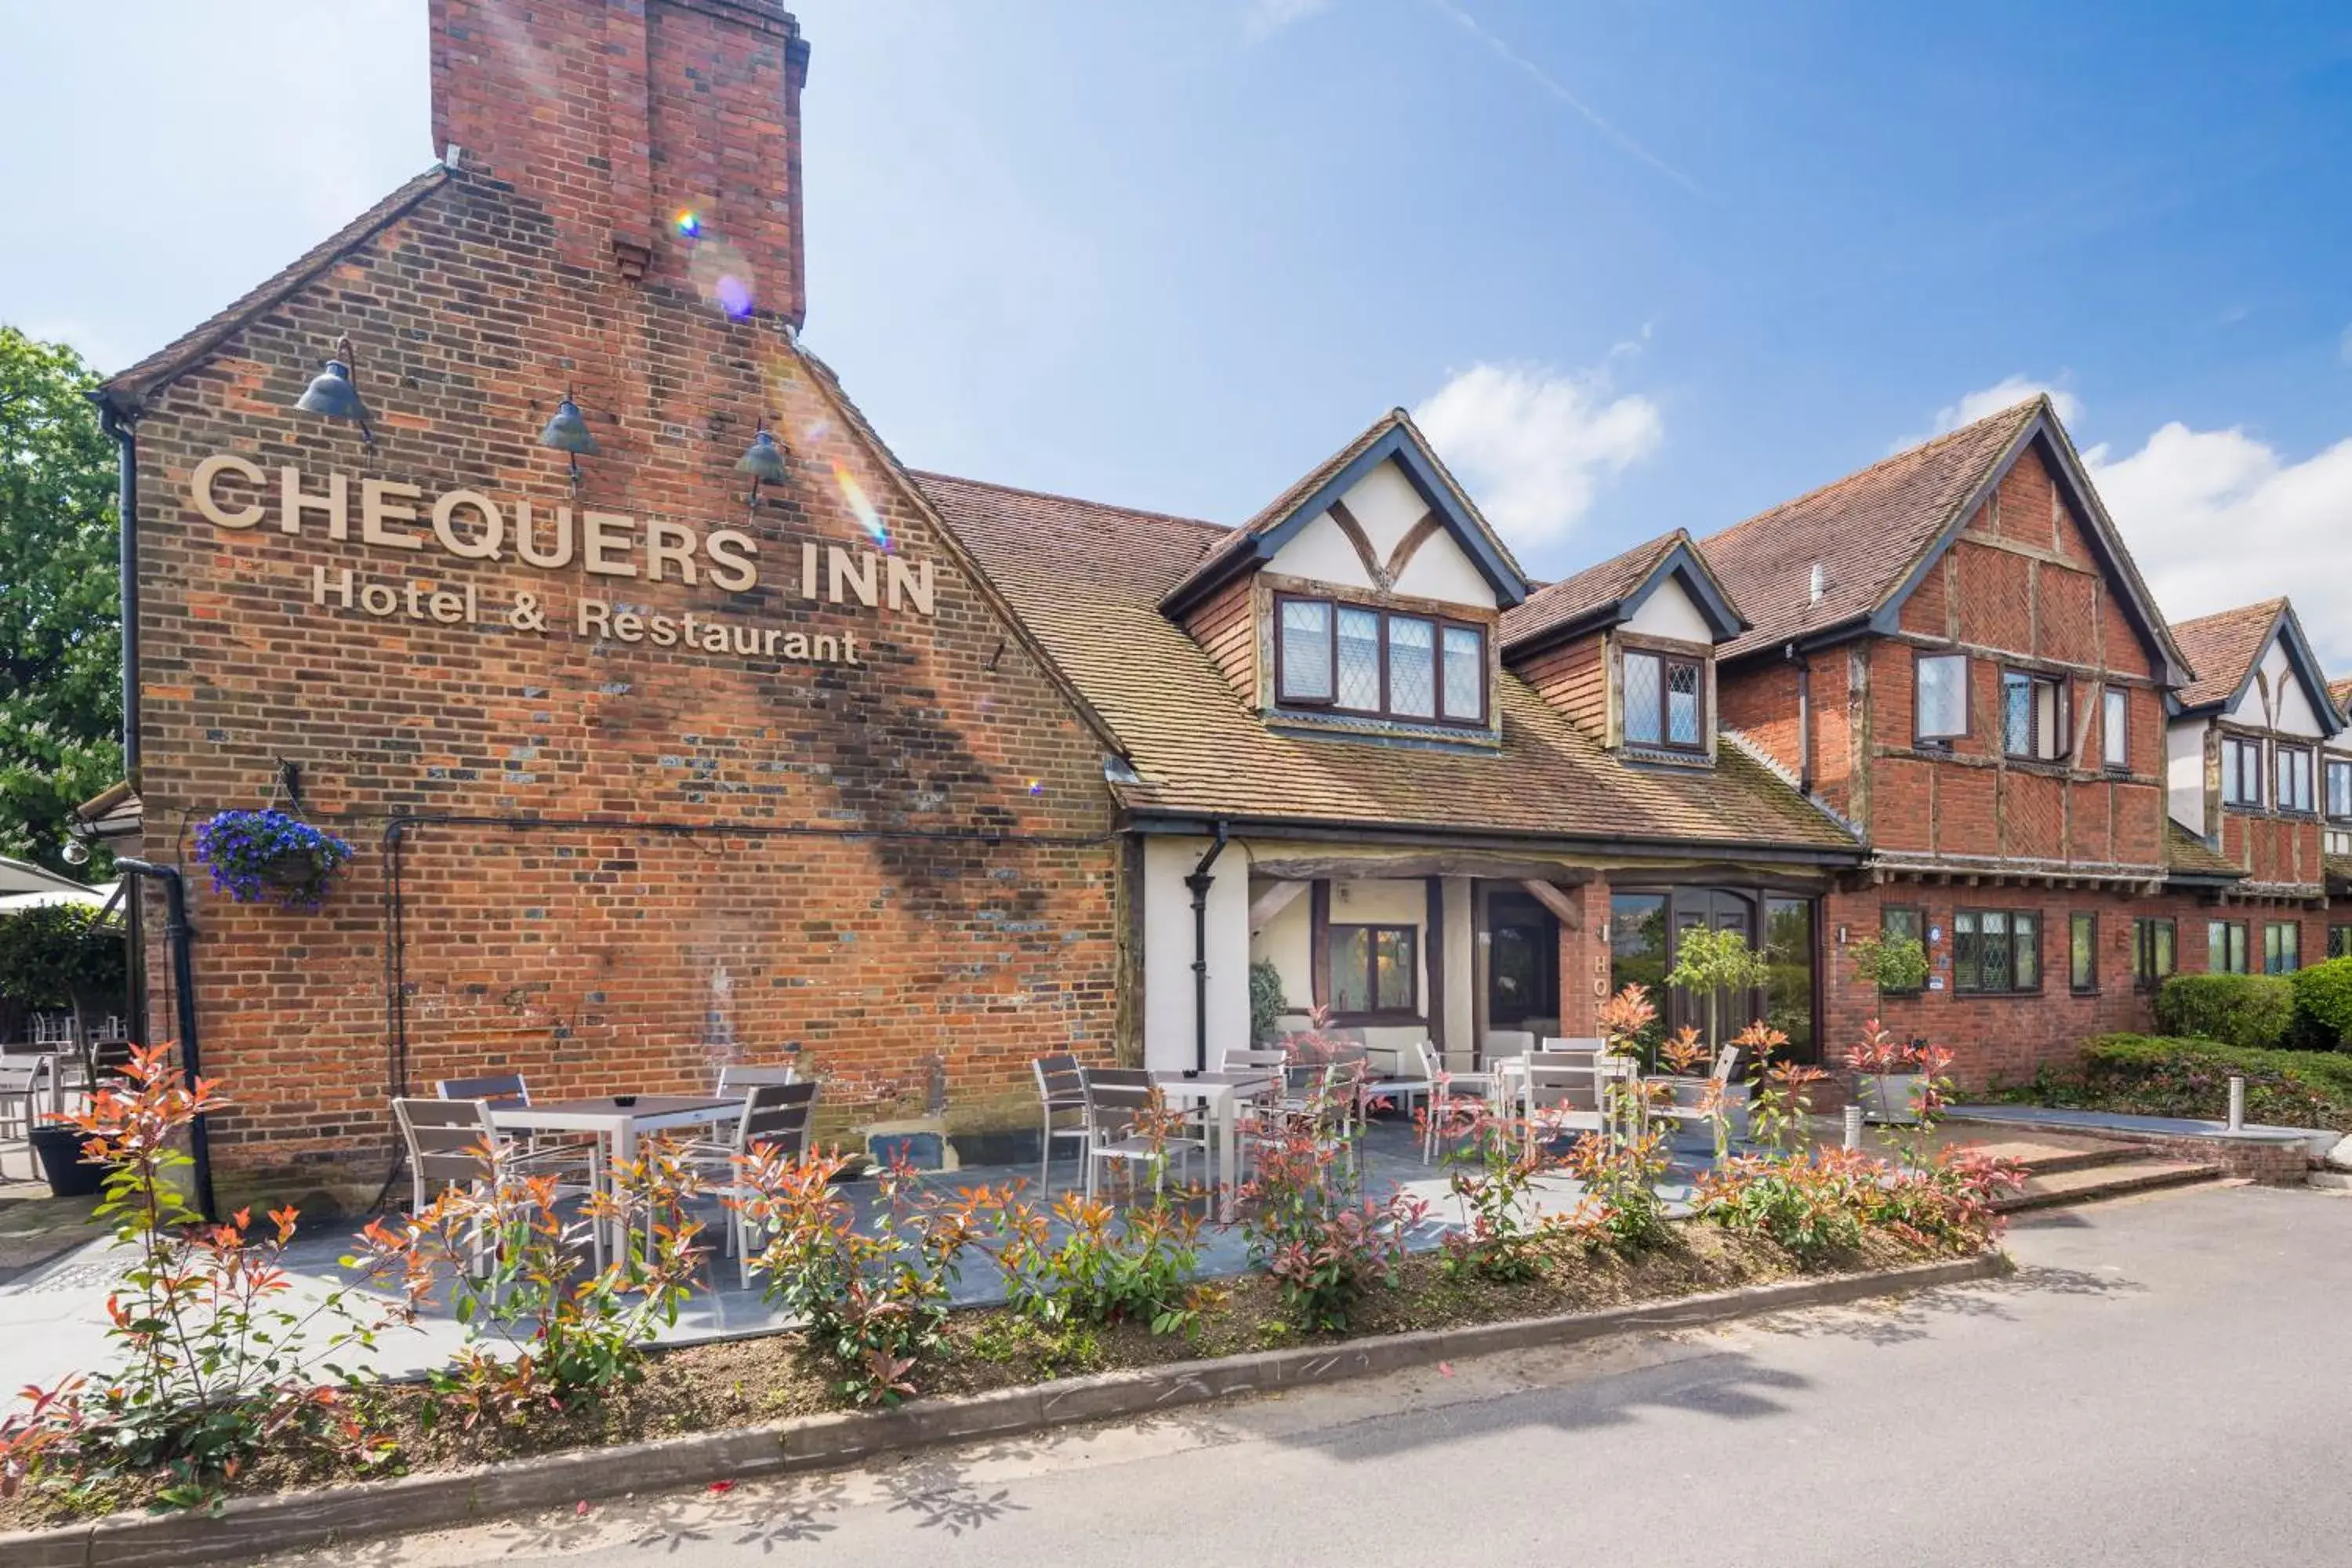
top-left (1275, 595), bottom-right (1486, 727)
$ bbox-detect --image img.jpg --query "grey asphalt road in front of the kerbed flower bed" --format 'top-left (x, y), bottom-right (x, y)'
top-left (280, 1187), bottom-right (2352, 1568)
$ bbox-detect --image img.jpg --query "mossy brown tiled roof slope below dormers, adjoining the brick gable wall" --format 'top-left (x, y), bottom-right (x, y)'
top-left (915, 475), bottom-right (1860, 855)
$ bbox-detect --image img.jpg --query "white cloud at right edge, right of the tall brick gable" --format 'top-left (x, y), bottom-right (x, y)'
top-left (2084, 421), bottom-right (2352, 670)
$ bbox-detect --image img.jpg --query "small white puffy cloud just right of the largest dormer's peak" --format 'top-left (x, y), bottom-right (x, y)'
top-left (1414, 365), bottom-right (1665, 548)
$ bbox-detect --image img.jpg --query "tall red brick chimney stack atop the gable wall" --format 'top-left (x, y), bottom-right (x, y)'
top-left (430, 0), bottom-right (809, 329)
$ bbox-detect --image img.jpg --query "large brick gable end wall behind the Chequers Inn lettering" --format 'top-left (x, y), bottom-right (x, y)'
top-left (124, 176), bottom-right (1131, 1196)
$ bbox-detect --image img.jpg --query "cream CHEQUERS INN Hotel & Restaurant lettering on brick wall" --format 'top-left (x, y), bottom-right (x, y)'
top-left (188, 452), bottom-right (936, 666)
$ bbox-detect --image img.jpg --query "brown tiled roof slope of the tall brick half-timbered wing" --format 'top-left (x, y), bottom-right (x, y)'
top-left (1700, 397), bottom-right (2044, 659)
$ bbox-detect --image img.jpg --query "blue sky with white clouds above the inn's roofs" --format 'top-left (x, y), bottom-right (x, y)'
top-left (0, 0), bottom-right (2352, 648)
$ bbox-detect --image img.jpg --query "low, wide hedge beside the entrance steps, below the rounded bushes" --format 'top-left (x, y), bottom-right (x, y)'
top-left (2079, 1034), bottom-right (2352, 1133)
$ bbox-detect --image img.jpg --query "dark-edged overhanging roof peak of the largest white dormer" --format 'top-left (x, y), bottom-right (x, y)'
top-left (1160, 409), bottom-right (1529, 616)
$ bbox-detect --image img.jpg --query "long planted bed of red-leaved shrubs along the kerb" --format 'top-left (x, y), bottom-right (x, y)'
top-left (0, 987), bottom-right (2023, 1528)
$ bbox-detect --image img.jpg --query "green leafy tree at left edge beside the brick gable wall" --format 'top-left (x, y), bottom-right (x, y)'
top-left (0, 325), bottom-right (122, 874)
